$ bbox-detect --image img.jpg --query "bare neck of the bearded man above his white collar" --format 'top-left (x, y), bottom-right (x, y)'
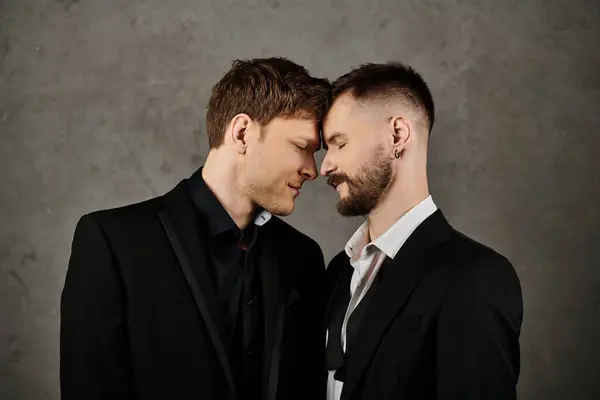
top-left (368, 162), bottom-right (429, 241)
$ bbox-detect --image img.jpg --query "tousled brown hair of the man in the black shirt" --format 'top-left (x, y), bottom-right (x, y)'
top-left (206, 57), bottom-right (331, 149)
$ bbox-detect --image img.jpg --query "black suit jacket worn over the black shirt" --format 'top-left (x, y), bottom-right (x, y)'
top-left (60, 175), bottom-right (326, 400)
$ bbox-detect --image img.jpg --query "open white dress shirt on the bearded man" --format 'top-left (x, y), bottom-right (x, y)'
top-left (327, 196), bottom-right (437, 400)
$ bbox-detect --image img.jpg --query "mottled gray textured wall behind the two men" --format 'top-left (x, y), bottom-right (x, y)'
top-left (0, 0), bottom-right (600, 400)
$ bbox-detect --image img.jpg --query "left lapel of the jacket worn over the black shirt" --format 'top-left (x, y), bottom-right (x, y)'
top-left (158, 182), bottom-right (235, 397)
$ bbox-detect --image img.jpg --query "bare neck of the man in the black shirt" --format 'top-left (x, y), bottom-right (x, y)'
top-left (202, 150), bottom-right (256, 229)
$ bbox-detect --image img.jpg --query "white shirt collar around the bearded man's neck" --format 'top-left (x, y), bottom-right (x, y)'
top-left (344, 195), bottom-right (437, 259)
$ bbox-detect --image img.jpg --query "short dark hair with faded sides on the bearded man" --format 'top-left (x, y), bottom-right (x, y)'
top-left (332, 62), bottom-right (435, 133)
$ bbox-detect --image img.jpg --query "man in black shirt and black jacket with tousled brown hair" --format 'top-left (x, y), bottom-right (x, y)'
top-left (60, 58), bottom-right (330, 400)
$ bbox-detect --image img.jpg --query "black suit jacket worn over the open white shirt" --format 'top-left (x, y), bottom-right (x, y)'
top-left (327, 210), bottom-right (523, 400)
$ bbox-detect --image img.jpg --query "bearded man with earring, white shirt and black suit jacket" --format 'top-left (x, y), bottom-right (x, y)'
top-left (321, 63), bottom-right (523, 400)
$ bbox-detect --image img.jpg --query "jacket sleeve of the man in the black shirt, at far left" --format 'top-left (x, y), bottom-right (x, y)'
top-left (60, 215), bottom-right (130, 400)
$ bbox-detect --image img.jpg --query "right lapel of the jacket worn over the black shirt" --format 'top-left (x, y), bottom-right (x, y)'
top-left (259, 220), bottom-right (287, 400)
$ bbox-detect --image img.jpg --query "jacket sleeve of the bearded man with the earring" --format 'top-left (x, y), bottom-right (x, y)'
top-left (437, 255), bottom-right (523, 400)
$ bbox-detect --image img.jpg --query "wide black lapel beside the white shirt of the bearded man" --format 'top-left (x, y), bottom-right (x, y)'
top-left (342, 210), bottom-right (451, 399)
